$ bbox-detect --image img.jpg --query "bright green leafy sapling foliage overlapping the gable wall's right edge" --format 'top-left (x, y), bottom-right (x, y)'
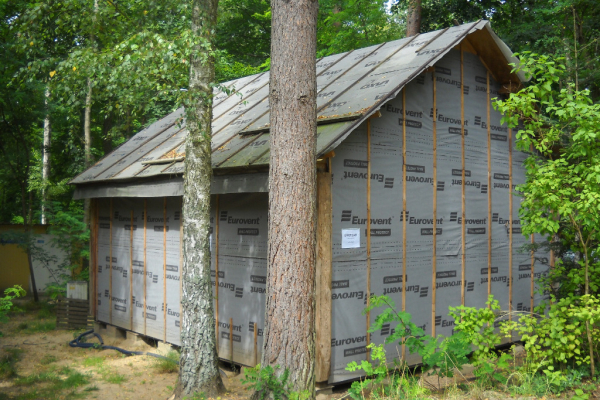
top-left (495, 54), bottom-right (600, 294)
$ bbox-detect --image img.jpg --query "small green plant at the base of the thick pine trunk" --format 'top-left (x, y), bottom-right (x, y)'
top-left (242, 364), bottom-right (310, 400)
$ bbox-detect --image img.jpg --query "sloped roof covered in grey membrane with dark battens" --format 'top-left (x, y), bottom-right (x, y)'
top-left (71, 21), bottom-right (524, 184)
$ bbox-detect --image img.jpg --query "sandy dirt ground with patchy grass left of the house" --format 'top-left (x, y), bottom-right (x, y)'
top-left (0, 302), bottom-right (345, 400)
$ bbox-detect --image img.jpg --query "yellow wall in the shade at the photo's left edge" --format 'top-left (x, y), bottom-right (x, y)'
top-left (0, 225), bottom-right (46, 295)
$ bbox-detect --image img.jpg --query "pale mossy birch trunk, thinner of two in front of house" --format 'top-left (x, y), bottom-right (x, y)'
top-left (175, 0), bottom-right (225, 399)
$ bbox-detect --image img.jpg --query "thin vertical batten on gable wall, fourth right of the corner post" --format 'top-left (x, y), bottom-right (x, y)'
top-left (460, 50), bottom-right (466, 306)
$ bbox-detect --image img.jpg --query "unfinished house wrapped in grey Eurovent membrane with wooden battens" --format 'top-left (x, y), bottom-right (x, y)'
top-left (72, 21), bottom-right (548, 383)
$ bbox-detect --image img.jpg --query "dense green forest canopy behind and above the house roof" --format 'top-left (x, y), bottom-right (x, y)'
top-left (0, 0), bottom-right (600, 252)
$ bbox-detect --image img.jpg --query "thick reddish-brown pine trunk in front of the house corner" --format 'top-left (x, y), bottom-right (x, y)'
top-left (254, 0), bottom-right (318, 397)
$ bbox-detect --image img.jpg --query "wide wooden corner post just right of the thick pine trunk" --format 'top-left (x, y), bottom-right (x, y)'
top-left (316, 159), bottom-right (332, 382)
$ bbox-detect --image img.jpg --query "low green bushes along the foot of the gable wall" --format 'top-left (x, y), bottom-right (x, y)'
top-left (346, 296), bottom-right (600, 400)
